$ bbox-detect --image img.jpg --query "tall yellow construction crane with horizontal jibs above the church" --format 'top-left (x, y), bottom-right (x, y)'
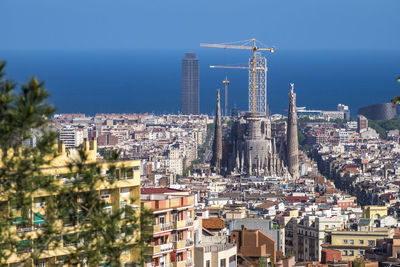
top-left (200, 38), bottom-right (275, 113)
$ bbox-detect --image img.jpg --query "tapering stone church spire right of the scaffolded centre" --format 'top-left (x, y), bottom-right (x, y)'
top-left (287, 83), bottom-right (299, 179)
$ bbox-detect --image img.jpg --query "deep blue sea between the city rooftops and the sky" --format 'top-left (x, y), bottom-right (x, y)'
top-left (0, 48), bottom-right (400, 115)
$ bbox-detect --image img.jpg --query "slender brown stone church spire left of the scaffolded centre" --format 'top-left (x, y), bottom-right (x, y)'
top-left (211, 89), bottom-right (222, 174)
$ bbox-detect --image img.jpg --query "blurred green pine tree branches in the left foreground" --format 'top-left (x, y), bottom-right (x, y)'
top-left (0, 61), bottom-right (151, 266)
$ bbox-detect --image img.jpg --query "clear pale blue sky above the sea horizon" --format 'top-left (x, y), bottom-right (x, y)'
top-left (0, 0), bottom-right (400, 50)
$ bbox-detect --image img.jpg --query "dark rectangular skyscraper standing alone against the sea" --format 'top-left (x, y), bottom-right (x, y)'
top-left (182, 53), bottom-right (200, 114)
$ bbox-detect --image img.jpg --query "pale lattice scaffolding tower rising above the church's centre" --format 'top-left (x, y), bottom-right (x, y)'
top-left (249, 53), bottom-right (268, 115)
